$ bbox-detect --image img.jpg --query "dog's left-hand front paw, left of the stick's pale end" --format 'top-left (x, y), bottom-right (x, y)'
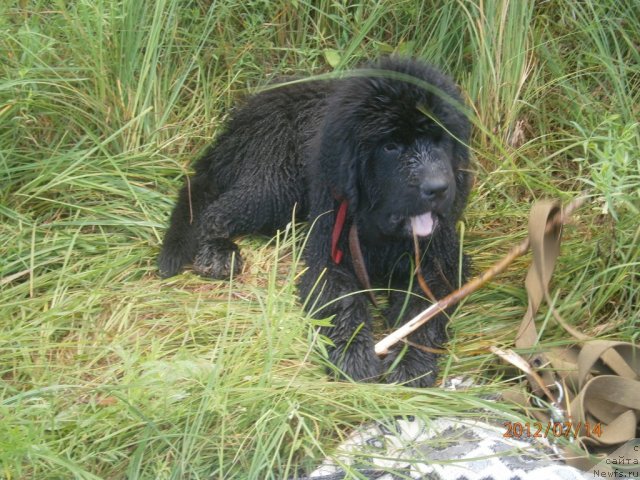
top-left (329, 342), bottom-right (382, 382)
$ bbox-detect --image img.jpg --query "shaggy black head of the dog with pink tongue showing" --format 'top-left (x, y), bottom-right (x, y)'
top-left (320, 58), bottom-right (470, 239)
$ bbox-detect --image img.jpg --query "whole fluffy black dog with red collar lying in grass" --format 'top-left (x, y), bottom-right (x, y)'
top-left (159, 58), bottom-right (471, 386)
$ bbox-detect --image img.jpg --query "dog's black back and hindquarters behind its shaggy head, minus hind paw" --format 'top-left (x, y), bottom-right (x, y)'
top-left (158, 81), bottom-right (334, 277)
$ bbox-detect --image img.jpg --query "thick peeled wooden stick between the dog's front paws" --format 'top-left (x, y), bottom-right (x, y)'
top-left (375, 197), bottom-right (587, 356)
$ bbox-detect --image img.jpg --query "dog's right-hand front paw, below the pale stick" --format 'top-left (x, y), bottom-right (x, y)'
top-left (383, 347), bottom-right (438, 387)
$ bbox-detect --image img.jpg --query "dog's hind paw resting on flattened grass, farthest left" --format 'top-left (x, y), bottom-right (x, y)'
top-left (193, 240), bottom-right (242, 280)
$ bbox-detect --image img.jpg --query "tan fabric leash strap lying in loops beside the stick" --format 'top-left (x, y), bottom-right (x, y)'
top-left (511, 201), bottom-right (640, 469)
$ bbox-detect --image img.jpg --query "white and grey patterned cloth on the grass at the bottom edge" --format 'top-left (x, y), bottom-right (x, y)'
top-left (295, 382), bottom-right (585, 480)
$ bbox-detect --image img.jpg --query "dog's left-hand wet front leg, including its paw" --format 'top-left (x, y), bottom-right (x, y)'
top-left (300, 265), bottom-right (381, 382)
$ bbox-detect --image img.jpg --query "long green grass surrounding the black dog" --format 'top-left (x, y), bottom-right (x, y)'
top-left (0, 0), bottom-right (640, 479)
